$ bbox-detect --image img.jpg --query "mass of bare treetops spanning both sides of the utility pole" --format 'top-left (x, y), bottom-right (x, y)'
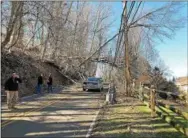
top-left (1, 1), bottom-right (185, 83)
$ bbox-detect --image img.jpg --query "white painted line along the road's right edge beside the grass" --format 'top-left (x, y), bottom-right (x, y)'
top-left (86, 101), bottom-right (107, 138)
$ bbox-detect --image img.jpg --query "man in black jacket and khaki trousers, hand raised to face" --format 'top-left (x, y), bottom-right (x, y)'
top-left (5, 73), bottom-right (22, 109)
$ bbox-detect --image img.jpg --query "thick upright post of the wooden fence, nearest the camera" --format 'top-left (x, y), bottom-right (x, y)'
top-left (150, 85), bottom-right (156, 117)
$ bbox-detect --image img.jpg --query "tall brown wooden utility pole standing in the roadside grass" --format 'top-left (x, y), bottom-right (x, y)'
top-left (123, 1), bottom-right (130, 96)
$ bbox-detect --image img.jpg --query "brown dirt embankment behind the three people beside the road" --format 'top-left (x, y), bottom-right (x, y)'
top-left (1, 51), bottom-right (71, 96)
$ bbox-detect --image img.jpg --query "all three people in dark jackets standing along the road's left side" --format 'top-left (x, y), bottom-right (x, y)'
top-left (5, 73), bottom-right (53, 110)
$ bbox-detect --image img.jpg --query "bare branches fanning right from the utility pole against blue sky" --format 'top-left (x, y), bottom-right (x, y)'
top-left (129, 2), bottom-right (186, 39)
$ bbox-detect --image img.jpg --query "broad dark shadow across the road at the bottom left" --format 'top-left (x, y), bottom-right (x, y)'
top-left (1, 120), bottom-right (91, 138)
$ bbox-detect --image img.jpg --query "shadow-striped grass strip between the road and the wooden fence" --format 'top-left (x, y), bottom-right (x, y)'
top-left (93, 98), bottom-right (185, 138)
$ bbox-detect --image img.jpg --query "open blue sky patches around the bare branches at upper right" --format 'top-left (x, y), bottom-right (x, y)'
top-left (108, 2), bottom-right (188, 77)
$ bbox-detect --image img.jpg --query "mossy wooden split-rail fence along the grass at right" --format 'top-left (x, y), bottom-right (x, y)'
top-left (134, 85), bottom-right (188, 136)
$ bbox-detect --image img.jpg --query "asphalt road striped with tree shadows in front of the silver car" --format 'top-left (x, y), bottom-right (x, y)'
top-left (1, 87), bottom-right (102, 138)
